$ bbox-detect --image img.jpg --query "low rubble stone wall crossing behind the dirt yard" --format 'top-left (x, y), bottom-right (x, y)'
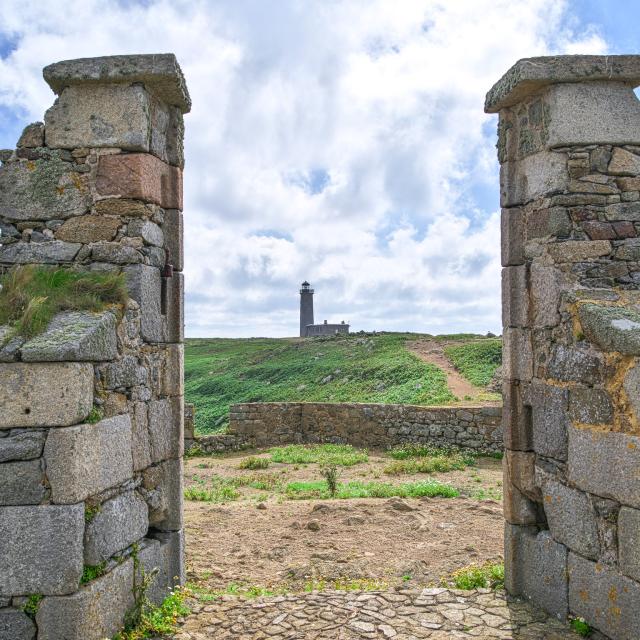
top-left (195, 402), bottom-right (503, 453)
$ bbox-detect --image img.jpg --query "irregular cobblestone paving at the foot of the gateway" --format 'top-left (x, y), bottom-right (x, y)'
top-left (174, 589), bottom-right (578, 640)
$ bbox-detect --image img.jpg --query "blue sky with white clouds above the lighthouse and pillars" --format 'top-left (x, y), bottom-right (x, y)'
top-left (0, 0), bottom-right (640, 337)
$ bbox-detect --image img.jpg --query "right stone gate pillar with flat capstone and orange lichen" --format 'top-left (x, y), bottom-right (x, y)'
top-left (485, 56), bottom-right (640, 640)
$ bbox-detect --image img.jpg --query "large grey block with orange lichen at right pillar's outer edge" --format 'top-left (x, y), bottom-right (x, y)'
top-left (567, 427), bottom-right (640, 508)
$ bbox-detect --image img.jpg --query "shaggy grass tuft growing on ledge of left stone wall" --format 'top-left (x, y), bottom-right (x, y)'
top-left (0, 265), bottom-right (128, 337)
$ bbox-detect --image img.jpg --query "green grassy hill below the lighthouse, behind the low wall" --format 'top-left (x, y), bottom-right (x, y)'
top-left (185, 333), bottom-right (500, 433)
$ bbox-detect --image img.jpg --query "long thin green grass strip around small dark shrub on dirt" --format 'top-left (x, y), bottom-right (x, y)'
top-left (284, 480), bottom-right (460, 500)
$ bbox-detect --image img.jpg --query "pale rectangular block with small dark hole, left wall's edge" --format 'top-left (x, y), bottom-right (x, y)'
top-left (0, 362), bottom-right (93, 429)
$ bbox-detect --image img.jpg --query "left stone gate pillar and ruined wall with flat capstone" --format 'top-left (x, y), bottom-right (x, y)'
top-left (0, 54), bottom-right (190, 640)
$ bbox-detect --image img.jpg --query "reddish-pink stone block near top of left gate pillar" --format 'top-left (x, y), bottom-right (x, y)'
top-left (96, 153), bottom-right (182, 210)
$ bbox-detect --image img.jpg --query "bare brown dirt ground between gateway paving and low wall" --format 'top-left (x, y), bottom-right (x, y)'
top-left (185, 453), bottom-right (503, 590)
